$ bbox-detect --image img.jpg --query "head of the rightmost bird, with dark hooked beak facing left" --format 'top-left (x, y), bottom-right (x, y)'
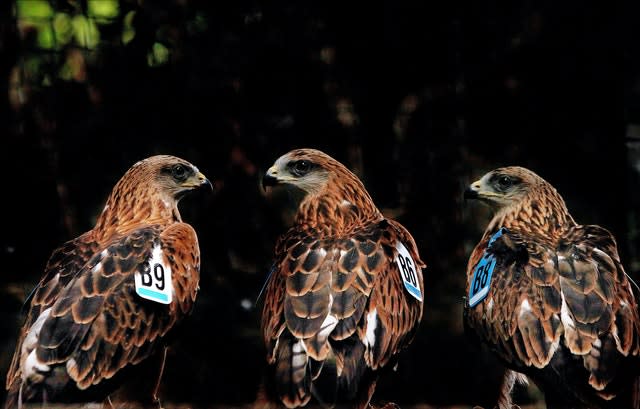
top-left (464, 166), bottom-right (544, 210)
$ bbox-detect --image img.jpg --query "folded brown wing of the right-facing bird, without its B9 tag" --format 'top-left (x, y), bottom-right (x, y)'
top-left (11, 224), bottom-right (199, 389)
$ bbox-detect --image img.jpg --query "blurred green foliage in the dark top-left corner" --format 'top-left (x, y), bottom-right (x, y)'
top-left (15, 0), bottom-right (175, 96)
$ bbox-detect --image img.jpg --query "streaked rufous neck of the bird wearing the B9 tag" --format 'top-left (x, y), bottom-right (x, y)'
top-left (94, 186), bottom-right (182, 239)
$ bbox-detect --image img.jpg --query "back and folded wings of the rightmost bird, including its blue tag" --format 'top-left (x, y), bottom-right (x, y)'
top-left (465, 225), bottom-right (640, 407)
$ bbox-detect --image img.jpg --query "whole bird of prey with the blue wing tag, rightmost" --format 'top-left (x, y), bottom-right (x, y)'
top-left (464, 166), bottom-right (640, 408)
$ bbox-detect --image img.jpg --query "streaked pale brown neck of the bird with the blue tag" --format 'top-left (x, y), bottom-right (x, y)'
top-left (486, 188), bottom-right (576, 241)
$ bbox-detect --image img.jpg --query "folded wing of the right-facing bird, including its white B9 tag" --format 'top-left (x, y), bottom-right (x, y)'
top-left (10, 223), bottom-right (199, 389)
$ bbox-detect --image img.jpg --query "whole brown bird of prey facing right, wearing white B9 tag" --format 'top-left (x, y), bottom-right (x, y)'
top-left (5, 155), bottom-right (212, 408)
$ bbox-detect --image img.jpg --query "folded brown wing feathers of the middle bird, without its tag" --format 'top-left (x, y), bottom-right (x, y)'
top-left (262, 221), bottom-right (424, 405)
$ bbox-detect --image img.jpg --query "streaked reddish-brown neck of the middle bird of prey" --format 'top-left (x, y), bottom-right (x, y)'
top-left (294, 189), bottom-right (383, 235)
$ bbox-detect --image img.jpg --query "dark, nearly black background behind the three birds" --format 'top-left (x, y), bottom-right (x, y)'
top-left (0, 0), bottom-right (640, 407)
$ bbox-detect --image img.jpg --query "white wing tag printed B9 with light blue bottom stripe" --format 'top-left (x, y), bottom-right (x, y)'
top-left (134, 246), bottom-right (173, 304)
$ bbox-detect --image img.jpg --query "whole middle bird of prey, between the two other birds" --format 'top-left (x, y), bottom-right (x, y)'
top-left (262, 149), bottom-right (425, 408)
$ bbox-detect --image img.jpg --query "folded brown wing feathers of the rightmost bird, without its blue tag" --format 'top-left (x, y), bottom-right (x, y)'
top-left (465, 226), bottom-right (640, 399)
